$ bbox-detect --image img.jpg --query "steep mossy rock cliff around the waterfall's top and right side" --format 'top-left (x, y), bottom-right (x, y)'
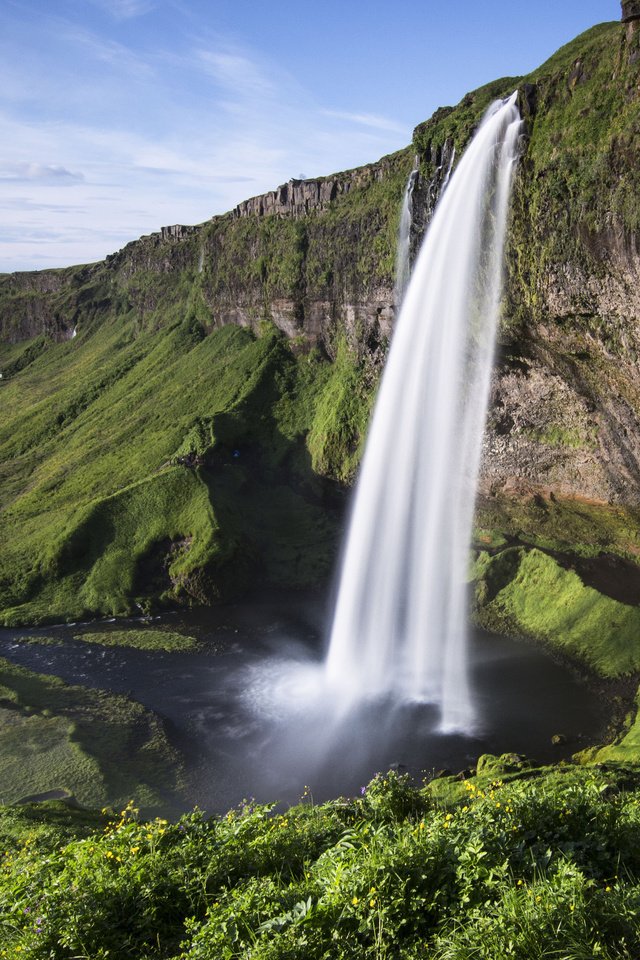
top-left (400, 18), bottom-right (640, 505)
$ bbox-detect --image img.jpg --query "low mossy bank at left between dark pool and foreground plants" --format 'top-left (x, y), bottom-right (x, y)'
top-left (0, 659), bottom-right (186, 812)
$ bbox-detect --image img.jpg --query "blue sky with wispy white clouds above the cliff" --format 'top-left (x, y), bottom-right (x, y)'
top-left (0, 0), bottom-right (620, 272)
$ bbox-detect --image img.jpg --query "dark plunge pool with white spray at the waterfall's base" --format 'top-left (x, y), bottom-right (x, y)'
top-left (0, 594), bottom-right (607, 812)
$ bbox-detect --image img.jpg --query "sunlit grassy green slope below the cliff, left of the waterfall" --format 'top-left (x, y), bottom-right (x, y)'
top-left (0, 318), bottom-right (376, 622)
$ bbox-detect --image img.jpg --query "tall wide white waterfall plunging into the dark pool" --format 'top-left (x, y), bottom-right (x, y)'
top-left (325, 93), bottom-right (520, 732)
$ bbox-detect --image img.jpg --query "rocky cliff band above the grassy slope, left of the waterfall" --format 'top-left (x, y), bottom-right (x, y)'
top-left (0, 150), bottom-right (412, 357)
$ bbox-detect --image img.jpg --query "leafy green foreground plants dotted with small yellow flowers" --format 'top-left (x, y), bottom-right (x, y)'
top-left (0, 758), bottom-right (640, 960)
